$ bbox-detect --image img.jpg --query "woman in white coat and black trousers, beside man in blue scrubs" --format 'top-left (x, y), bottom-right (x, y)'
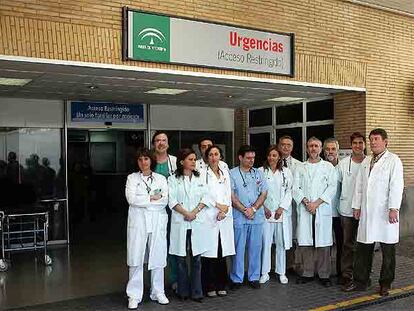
top-left (202, 145), bottom-right (235, 297)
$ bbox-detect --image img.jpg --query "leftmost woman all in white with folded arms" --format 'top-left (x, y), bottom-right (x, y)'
top-left (125, 149), bottom-right (169, 309)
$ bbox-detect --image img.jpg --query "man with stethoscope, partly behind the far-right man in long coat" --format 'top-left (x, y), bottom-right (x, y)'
top-left (337, 132), bottom-right (365, 288)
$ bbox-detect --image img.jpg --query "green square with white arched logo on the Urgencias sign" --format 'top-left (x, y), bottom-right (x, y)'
top-left (130, 12), bottom-right (170, 62)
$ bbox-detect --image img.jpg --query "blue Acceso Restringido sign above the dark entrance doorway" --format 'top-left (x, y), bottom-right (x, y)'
top-left (71, 102), bottom-right (144, 123)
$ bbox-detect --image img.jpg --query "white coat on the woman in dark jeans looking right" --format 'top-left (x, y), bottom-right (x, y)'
top-left (168, 175), bottom-right (211, 257)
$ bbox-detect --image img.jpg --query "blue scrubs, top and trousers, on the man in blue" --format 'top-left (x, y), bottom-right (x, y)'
top-left (230, 166), bottom-right (267, 283)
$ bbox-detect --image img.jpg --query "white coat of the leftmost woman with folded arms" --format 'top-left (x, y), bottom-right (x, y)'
top-left (125, 173), bottom-right (168, 270)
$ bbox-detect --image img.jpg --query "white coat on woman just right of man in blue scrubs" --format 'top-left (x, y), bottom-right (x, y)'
top-left (259, 167), bottom-right (293, 249)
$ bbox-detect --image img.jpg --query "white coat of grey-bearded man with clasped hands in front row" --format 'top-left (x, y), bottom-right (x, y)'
top-left (293, 160), bottom-right (337, 247)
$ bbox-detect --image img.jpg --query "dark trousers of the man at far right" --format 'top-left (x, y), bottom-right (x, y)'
top-left (354, 242), bottom-right (395, 287)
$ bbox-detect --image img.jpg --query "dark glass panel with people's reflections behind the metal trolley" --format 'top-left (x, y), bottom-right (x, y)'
top-left (0, 128), bottom-right (68, 244)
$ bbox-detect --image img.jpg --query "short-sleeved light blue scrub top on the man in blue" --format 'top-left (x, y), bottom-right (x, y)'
top-left (230, 166), bottom-right (267, 225)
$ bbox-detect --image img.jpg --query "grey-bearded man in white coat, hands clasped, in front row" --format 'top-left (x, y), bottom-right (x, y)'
top-left (293, 137), bottom-right (337, 287)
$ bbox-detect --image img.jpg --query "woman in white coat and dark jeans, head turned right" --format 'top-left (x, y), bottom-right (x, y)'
top-left (168, 149), bottom-right (208, 302)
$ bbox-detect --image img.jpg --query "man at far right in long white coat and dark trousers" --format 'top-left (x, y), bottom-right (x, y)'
top-left (344, 128), bottom-right (404, 296)
